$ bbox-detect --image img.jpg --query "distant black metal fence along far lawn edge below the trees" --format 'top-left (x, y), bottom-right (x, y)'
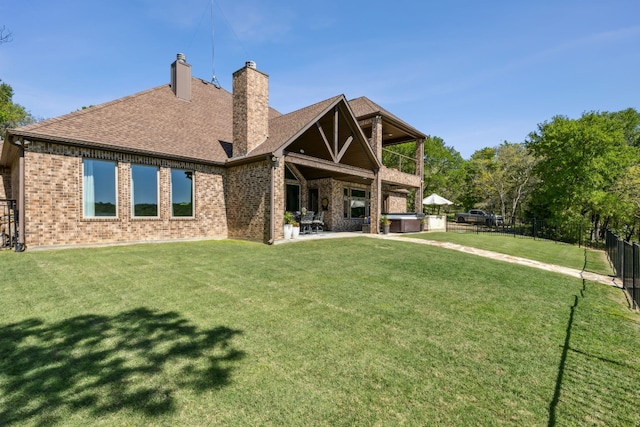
top-left (447, 218), bottom-right (584, 246)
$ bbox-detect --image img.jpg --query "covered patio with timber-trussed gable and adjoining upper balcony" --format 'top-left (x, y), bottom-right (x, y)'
top-left (275, 98), bottom-right (425, 237)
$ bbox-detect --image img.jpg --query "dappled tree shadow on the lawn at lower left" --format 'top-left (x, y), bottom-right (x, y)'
top-left (0, 308), bottom-right (244, 425)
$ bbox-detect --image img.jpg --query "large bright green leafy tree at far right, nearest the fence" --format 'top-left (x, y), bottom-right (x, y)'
top-left (526, 109), bottom-right (640, 238)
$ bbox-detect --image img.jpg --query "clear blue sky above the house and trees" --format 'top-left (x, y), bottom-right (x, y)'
top-left (0, 0), bottom-right (640, 158)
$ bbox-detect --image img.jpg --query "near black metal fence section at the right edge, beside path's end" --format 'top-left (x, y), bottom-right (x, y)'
top-left (605, 230), bottom-right (640, 308)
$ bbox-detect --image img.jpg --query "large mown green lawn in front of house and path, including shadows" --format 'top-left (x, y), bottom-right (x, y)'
top-left (0, 238), bottom-right (640, 426)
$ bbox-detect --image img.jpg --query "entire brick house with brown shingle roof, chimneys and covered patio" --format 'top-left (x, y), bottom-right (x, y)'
top-left (0, 54), bottom-right (426, 247)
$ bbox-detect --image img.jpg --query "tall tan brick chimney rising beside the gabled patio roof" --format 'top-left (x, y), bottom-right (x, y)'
top-left (233, 61), bottom-right (269, 157)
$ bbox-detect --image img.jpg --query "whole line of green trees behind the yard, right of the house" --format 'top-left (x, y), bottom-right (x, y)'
top-left (389, 108), bottom-right (640, 241)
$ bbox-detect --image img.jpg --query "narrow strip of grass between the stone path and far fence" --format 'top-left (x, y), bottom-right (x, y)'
top-left (405, 232), bottom-right (613, 275)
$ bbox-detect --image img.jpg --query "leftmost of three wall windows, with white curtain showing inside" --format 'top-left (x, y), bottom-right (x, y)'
top-left (82, 159), bottom-right (117, 218)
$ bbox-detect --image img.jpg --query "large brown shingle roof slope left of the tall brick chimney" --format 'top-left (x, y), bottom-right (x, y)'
top-left (10, 78), bottom-right (280, 163)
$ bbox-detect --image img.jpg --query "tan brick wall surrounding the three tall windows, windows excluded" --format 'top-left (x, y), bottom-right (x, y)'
top-left (23, 141), bottom-right (227, 247)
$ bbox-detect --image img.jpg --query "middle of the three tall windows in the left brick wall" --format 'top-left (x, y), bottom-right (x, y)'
top-left (131, 165), bottom-right (158, 217)
